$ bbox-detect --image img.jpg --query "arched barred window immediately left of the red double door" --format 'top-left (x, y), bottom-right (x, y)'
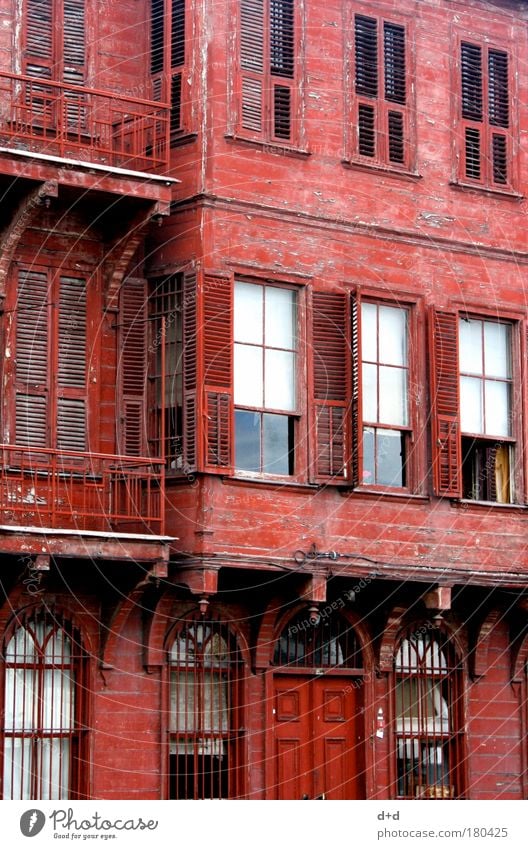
top-left (169, 619), bottom-right (243, 799)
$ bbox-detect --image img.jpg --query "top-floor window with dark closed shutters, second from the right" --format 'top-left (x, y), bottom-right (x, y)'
top-left (351, 14), bottom-right (411, 169)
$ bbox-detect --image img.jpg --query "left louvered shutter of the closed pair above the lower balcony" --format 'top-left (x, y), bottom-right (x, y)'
top-left (15, 268), bottom-right (50, 448)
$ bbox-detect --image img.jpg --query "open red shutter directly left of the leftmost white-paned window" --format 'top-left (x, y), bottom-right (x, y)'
top-left (203, 274), bottom-right (233, 474)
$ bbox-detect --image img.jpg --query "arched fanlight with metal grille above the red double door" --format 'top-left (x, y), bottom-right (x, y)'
top-left (273, 610), bottom-right (363, 669)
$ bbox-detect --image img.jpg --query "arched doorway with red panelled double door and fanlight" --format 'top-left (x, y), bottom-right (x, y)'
top-left (267, 610), bottom-right (365, 799)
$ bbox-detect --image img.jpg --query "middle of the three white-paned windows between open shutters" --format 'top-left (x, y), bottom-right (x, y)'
top-left (361, 302), bottom-right (409, 487)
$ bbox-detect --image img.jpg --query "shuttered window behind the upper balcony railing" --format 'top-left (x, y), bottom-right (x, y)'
top-left (21, 0), bottom-right (86, 131)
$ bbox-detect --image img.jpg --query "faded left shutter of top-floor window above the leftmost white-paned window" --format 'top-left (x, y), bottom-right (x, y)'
top-left (240, 0), bottom-right (264, 135)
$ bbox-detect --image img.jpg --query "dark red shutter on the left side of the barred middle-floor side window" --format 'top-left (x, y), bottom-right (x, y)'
top-left (118, 279), bottom-right (147, 457)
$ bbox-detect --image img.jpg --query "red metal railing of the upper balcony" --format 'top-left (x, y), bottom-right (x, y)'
top-left (0, 72), bottom-right (170, 172)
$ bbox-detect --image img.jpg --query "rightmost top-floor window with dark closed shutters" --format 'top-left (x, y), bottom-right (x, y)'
top-left (459, 40), bottom-right (513, 189)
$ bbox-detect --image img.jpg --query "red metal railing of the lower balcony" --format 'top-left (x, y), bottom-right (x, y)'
top-left (0, 445), bottom-right (165, 534)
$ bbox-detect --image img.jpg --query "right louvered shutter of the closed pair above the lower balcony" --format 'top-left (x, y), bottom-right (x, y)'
top-left (56, 276), bottom-right (87, 451)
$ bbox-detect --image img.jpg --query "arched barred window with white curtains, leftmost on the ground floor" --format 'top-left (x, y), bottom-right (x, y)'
top-left (3, 611), bottom-right (86, 799)
